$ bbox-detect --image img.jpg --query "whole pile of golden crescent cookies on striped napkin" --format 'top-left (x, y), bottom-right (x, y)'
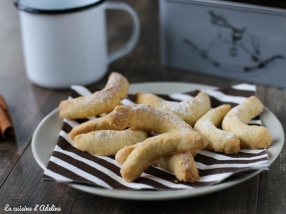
top-left (59, 72), bottom-right (272, 182)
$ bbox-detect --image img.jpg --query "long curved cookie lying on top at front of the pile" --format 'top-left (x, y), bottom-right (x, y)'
top-left (120, 131), bottom-right (204, 182)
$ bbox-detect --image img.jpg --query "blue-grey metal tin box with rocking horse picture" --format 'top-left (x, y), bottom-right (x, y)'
top-left (160, 0), bottom-right (286, 87)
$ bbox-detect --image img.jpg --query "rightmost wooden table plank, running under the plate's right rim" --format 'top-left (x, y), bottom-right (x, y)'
top-left (257, 87), bottom-right (286, 213)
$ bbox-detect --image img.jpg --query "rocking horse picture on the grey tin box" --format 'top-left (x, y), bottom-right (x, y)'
top-left (183, 11), bottom-right (285, 73)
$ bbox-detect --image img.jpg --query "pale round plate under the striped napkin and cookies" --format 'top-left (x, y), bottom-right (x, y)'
top-left (32, 82), bottom-right (284, 200)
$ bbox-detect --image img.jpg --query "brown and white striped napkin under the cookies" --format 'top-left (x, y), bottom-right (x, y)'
top-left (43, 84), bottom-right (269, 190)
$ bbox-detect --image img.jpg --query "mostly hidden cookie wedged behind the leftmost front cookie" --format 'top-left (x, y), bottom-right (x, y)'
top-left (69, 114), bottom-right (121, 139)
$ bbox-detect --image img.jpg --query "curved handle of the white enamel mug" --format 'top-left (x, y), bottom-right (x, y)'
top-left (106, 1), bottom-right (140, 63)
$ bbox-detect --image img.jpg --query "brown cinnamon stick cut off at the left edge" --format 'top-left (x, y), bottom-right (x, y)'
top-left (0, 95), bottom-right (15, 141)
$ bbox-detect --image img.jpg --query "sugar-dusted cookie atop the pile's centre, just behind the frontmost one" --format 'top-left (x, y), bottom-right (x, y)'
top-left (108, 104), bottom-right (193, 133)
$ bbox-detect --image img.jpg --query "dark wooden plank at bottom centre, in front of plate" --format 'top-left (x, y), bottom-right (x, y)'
top-left (113, 176), bottom-right (258, 214)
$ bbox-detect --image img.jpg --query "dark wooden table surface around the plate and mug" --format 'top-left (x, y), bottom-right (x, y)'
top-left (0, 0), bottom-right (286, 214)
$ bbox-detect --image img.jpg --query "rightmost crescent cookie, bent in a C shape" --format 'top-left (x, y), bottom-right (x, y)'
top-left (222, 96), bottom-right (272, 149)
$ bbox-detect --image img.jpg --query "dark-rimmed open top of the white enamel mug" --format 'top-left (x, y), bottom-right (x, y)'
top-left (14, 0), bottom-right (105, 13)
